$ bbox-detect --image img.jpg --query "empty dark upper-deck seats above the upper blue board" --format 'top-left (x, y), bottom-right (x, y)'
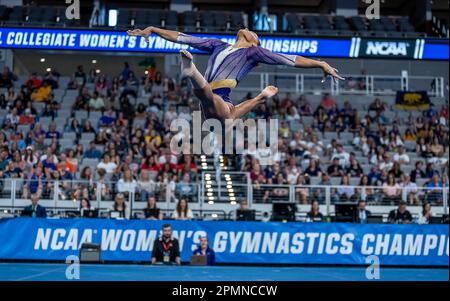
top-left (0, 6), bottom-right (425, 38)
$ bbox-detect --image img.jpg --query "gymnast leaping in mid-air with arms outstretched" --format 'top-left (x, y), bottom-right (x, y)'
top-left (127, 26), bottom-right (344, 121)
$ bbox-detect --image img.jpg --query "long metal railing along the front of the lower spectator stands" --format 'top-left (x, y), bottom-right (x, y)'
top-left (0, 179), bottom-right (449, 218)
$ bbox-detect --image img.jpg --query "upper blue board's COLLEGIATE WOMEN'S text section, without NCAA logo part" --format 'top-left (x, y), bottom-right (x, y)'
top-left (0, 28), bottom-right (351, 57)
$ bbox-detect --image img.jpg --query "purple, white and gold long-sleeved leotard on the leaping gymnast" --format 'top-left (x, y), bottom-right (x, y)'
top-left (177, 33), bottom-right (296, 102)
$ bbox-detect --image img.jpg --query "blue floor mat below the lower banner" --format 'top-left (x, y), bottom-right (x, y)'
top-left (0, 263), bottom-right (449, 281)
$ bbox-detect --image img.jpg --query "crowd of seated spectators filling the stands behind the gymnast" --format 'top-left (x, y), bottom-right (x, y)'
top-left (0, 63), bottom-right (449, 216)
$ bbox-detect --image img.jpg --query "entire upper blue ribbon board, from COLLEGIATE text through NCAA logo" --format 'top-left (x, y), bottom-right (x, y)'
top-left (0, 27), bottom-right (448, 60)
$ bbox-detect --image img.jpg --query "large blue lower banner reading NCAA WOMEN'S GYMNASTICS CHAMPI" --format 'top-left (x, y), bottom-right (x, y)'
top-left (0, 218), bottom-right (449, 266)
